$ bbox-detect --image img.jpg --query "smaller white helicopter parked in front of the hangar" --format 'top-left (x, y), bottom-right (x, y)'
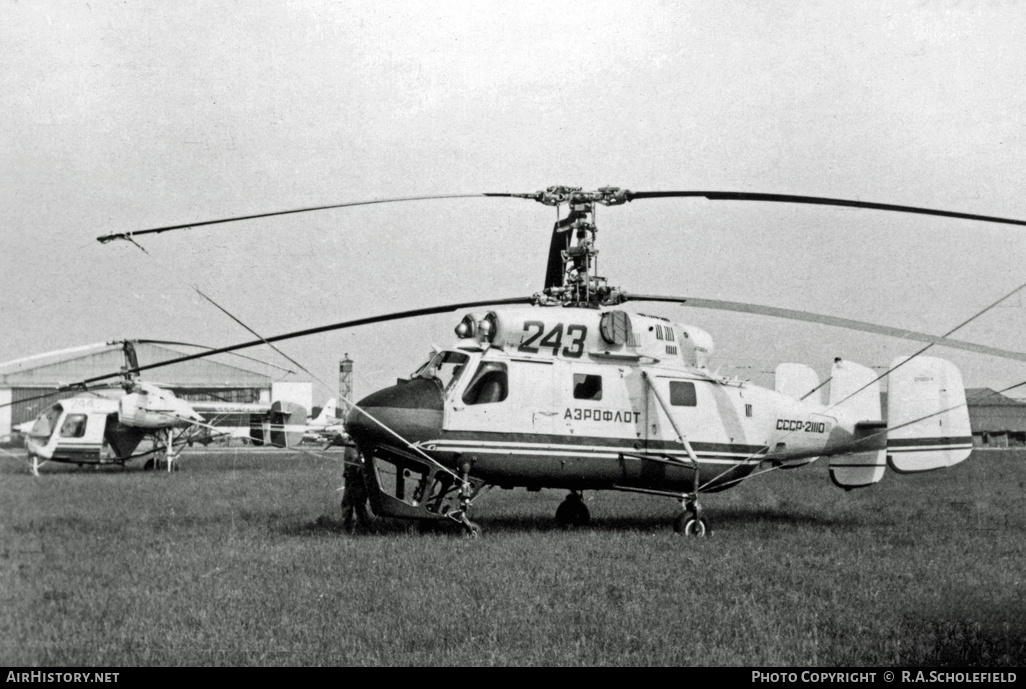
top-left (19, 340), bottom-right (306, 476)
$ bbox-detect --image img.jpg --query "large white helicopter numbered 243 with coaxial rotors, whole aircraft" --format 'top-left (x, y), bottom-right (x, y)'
top-left (97, 187), bottom-right (1026, 536)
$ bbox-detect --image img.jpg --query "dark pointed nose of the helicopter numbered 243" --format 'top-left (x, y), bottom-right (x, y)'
top-left (346, 378), bottom-right (442, 447)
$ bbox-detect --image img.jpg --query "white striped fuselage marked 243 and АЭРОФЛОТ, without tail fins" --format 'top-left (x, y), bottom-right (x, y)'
top-left (354, 308), bottom-right (885, 490)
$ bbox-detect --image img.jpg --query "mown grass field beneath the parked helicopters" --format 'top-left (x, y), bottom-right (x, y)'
top-left (0, 451), bottom-right (1026, 666)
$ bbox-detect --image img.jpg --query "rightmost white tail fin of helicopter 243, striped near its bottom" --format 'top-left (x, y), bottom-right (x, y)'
top-left (887, 357), bottom-right (973, 474)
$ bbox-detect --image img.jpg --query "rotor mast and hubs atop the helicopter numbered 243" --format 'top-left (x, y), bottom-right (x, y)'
top-left (514, 187), bottom-right (629, 309)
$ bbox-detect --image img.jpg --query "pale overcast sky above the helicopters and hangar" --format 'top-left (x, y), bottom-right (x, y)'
top-left (0, 0), bottom-right (1026, 403)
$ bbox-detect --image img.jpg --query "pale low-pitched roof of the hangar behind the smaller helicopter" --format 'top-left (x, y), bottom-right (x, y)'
top-left (0, 342), bottom-right (272, 388)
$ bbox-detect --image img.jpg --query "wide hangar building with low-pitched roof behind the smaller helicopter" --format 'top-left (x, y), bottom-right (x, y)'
top-left (0, 342), bottom-right (299, 438)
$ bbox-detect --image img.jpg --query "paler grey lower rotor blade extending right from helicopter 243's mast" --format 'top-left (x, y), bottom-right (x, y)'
top-left (624, 294), bottom-right (1026, 361)
